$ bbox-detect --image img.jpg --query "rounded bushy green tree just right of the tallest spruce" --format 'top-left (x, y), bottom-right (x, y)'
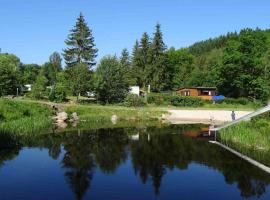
top-left (95, 56), bottom-right (129, 103)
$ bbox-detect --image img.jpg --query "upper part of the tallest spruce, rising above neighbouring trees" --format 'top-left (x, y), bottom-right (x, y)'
top-left (63, 13), bottom-right (98, 69)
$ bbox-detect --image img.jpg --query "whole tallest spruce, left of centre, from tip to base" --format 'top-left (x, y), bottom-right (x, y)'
top-left (63, 14), bottom-right (98, 101)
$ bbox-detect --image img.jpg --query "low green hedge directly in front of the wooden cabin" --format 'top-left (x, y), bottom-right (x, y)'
top-left (171, 96), bottom-right (204, 107)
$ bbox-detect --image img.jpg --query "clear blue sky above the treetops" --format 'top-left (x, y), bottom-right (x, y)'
top-left (0, 0), bottom-right (270, 64)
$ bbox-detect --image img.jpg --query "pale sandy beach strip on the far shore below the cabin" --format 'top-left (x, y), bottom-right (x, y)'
top-left (165, 110), bottom-right (252, 124)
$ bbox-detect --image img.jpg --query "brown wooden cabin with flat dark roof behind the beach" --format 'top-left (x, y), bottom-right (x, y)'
top-left (178, 87), bottom-right (217, 100)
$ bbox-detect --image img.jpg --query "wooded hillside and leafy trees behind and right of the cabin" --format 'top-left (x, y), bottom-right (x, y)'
top-left (168, 29), bottom-right (270, 99)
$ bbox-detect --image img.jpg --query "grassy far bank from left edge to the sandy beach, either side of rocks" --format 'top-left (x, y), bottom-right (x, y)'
top-left (0, 99), bottom-right (166, 135)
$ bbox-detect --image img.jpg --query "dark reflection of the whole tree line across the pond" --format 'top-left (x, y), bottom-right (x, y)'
top-left (0, 126), bottom-right (270, 199)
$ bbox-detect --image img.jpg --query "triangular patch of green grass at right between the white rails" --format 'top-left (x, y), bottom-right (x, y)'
top-left (219, 113), bottom-right (270, 166)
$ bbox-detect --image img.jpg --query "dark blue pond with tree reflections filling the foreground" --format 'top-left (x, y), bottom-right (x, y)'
top-left (0, 125), bottom-right (270, 200)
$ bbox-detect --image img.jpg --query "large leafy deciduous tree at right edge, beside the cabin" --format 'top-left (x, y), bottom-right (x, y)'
top-left (218, 29), bottom-right (268, 99)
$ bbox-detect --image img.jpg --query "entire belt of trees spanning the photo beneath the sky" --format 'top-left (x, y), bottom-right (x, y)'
top-left (0, 14), bottom-right (270, 103)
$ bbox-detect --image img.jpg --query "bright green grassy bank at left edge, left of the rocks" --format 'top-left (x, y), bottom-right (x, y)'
top-left (0, 99), bottom-right (52, 134)
